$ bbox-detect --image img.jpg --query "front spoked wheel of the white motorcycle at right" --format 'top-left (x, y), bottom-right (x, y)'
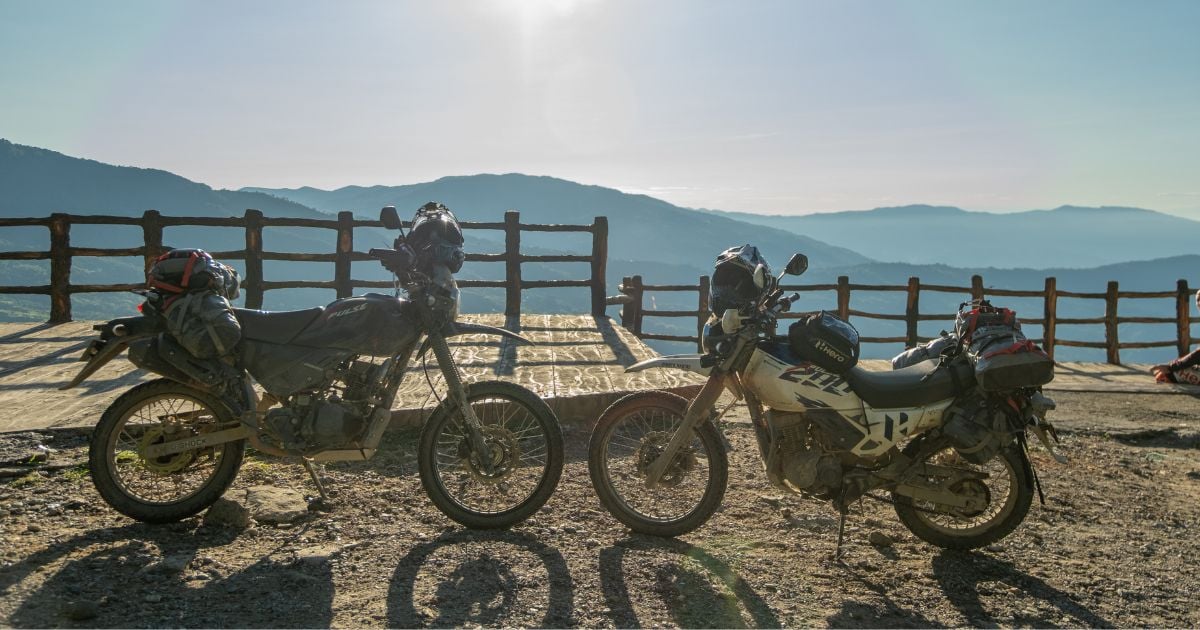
top-left (588, 391), bottom-right (730, 536)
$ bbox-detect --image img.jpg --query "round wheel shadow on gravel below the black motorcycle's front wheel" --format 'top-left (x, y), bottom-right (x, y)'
top-left (388, 529), bottom-right (577, 628)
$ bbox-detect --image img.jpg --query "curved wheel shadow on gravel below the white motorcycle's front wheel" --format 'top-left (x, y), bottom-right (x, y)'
top-left (600, 534), bottom-right (782, 628)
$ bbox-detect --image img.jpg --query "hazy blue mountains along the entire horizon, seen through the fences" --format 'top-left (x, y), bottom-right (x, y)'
top-left (0, 140), bottom-right (1200, 360)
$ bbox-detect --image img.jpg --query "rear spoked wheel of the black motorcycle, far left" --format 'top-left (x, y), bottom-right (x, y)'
top-left (88, 379), bottom-right (246, 523)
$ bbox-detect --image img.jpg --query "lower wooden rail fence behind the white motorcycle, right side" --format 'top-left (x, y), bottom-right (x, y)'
top-left (608, 271), bottom-right (1200, 364)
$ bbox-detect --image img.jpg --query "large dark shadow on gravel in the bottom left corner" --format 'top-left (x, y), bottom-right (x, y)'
top-left (0, 523), bottom-right (334, 628)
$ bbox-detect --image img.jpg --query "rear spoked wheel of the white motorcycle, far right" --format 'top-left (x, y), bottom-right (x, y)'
top-left (892, 442), bottom-right (1033, 550)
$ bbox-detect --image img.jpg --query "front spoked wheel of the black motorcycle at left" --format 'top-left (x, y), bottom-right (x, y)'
top-left (418, 380), bottom-right (563, 529)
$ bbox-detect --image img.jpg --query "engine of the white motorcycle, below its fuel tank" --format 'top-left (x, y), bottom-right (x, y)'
top-left (767, 409), bottom-right (842, 499)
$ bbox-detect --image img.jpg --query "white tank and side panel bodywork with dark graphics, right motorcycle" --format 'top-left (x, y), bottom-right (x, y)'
top-left (743, 343), bottom-right (954, 457)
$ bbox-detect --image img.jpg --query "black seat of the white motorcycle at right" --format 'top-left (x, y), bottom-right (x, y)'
top-left (842, 359), bottom-right (976, 409)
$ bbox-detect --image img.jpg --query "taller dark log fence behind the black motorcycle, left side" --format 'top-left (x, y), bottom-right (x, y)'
top-left (0, 210), bottom-right (608, 323)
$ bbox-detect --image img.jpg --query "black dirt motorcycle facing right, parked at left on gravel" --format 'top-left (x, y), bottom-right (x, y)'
top-left (62, 204), bottom-right (563, 528)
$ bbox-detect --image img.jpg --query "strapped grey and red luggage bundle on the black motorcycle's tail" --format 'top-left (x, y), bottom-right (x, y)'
top-left (146, 250), bottom-right (241, 359)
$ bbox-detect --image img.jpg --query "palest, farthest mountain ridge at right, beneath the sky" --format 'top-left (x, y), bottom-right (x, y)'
top-left (707, 205), bottom-right (1200, 269)
